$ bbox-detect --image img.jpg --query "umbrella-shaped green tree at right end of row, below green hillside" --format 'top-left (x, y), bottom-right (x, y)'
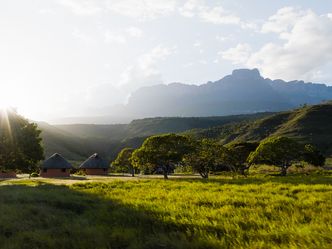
top-left (248, 137), bottom-right (303, 175)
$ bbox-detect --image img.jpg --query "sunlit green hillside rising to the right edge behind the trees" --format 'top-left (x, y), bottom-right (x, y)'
top-left (186, 102), bottom-right (332, 155)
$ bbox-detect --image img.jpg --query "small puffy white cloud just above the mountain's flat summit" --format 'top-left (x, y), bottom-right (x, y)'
top-left (219, 43), bottom-right (252, 65)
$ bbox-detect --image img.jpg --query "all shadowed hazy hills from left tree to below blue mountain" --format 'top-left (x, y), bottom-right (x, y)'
top-left (38, 113), bottom-right (270, 160)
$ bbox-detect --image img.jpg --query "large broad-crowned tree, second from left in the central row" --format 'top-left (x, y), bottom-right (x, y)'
top-left (131, 134), bottom-right (191, 179)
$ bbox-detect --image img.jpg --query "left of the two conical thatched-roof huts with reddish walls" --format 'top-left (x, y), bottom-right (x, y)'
top-left (40, 153), bottom-right (72, 177)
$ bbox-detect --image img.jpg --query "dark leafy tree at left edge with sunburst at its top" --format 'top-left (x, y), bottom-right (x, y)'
top-left (0, 110), bottom-right (44, 173)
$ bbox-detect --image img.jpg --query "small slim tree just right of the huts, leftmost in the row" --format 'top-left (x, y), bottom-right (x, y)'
top-left (112, 148), bottom-right (135, 176)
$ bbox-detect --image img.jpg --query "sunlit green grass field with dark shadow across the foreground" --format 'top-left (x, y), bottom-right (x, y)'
top-left (0, 175), bottom-right (332, 249)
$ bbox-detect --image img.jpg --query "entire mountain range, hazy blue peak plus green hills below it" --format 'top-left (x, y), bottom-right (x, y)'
top-left (38, 69), bottom-right (332, 161)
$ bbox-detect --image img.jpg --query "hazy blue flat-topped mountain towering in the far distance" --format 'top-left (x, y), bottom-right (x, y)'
top-left (125, 69), bottom-right (332, 117)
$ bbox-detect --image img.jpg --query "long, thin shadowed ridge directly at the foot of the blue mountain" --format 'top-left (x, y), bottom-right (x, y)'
top-left (53, 113), bottom-right (271, 141)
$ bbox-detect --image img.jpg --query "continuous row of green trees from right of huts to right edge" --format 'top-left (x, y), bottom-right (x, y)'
top-left (111, 134), bottom-right (325, 179)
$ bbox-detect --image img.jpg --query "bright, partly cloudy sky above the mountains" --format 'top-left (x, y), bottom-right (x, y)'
top-left (0, 0), bottom-right (332, 121)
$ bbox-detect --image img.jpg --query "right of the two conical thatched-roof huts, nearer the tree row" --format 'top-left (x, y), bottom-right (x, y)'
top-left (80, 153), bottom-right (109, 175)
